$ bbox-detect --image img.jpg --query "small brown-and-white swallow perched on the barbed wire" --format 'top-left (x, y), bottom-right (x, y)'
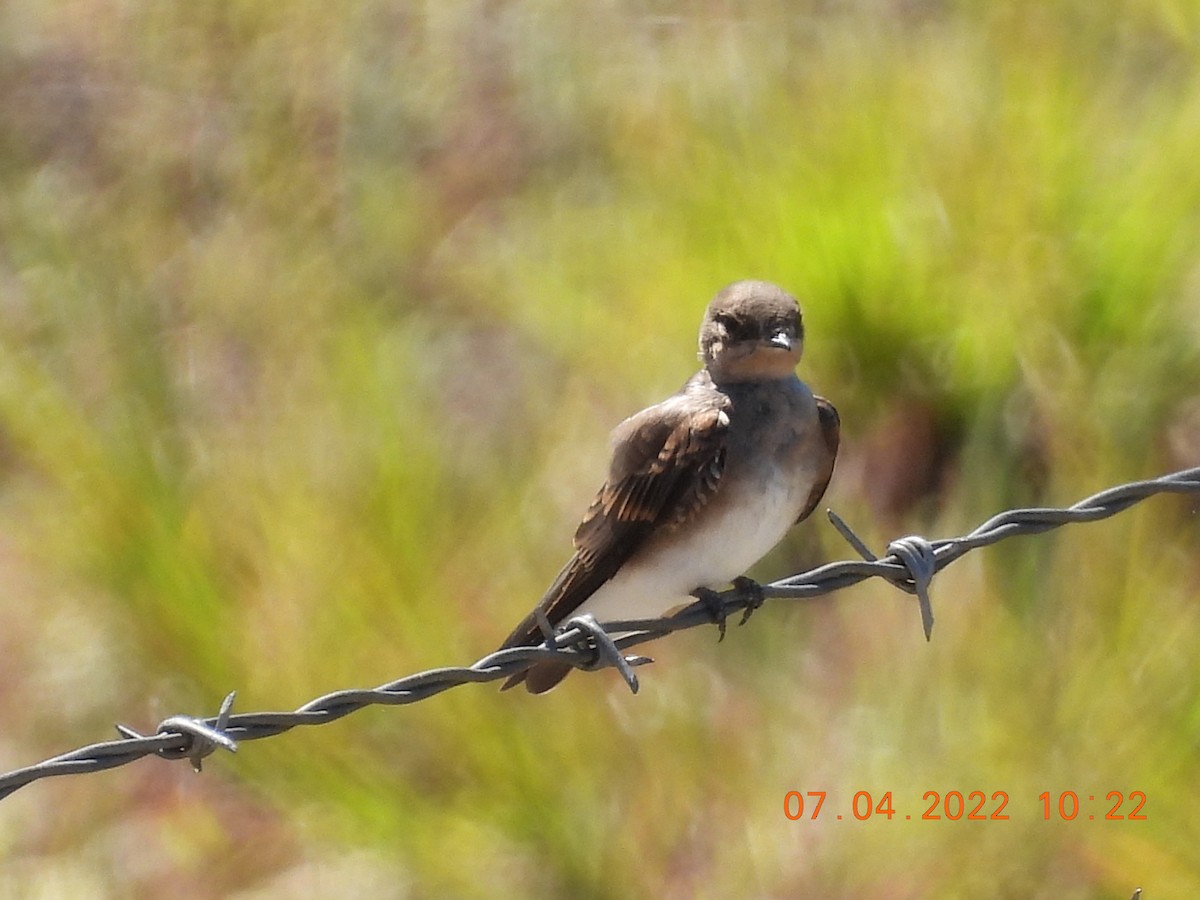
top-left (500, 281), bottom-right (841, 694)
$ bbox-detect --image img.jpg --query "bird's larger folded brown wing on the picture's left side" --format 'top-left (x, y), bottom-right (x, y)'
top-left (502, 395), bottom-right (730, 648)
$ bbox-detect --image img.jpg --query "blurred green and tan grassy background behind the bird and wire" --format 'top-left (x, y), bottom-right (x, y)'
top-left (0, 0), bottom-right (1200, 900)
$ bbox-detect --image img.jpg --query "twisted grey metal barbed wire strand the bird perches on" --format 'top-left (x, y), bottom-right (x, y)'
top-left (0, 468), bottom-right (1200, 799)
